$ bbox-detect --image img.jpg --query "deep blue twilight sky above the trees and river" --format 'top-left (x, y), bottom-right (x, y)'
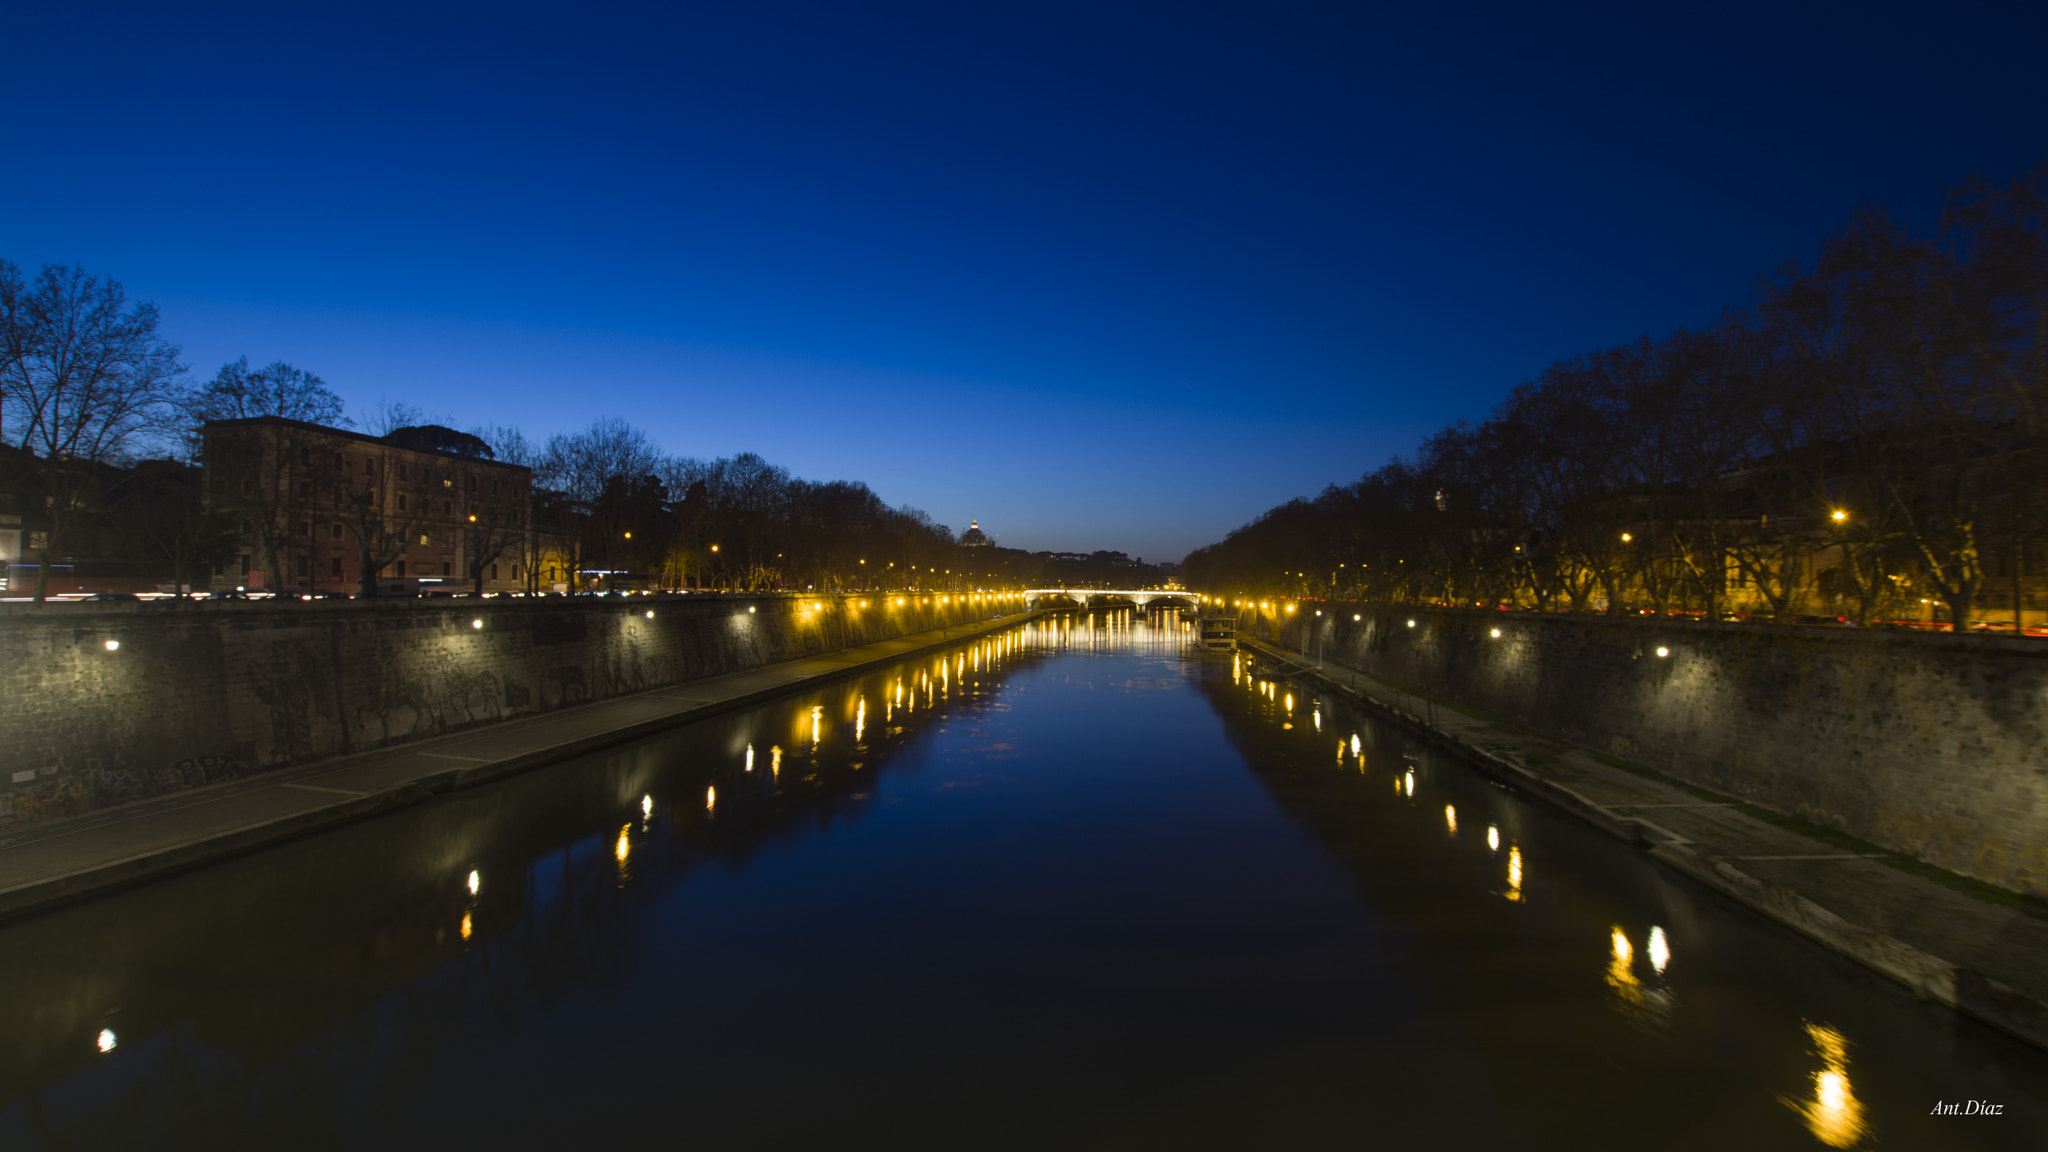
top-left (0, 0), bottom-right (2048, 560)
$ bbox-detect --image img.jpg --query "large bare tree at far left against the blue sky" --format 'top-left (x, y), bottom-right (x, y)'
top-left (0, 262), bottom-right (184, 603)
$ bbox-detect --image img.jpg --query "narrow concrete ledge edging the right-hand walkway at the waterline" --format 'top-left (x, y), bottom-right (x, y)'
top-left (1239, 635), bottom-right (2048, 1050)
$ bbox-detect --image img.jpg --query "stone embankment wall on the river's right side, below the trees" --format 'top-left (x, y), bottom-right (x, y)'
top-left (1241, 603), bottom-right (2048, 896)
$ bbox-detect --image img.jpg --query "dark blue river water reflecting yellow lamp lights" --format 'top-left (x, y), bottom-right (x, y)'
top-left (0, 613), bottom-right (2048, 1152)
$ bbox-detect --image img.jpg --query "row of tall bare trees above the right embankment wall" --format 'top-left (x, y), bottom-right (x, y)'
top-left (1186, 164), bottom-right (2048, 629)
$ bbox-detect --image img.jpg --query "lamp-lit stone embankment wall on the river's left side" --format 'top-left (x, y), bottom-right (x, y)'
top-left (0, 592), bottom-right (1022, 826)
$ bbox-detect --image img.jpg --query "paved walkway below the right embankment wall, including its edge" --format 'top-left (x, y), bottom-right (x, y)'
top-left (1239, 637), bottom-right (2048, 1047)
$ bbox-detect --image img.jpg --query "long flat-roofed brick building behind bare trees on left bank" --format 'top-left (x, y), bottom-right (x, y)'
top-left (201, 416), bottom-right (532, 594)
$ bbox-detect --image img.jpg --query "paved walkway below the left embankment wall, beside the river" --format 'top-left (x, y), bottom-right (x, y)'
top-left (0, 613), bottom-right (1038, 918)
